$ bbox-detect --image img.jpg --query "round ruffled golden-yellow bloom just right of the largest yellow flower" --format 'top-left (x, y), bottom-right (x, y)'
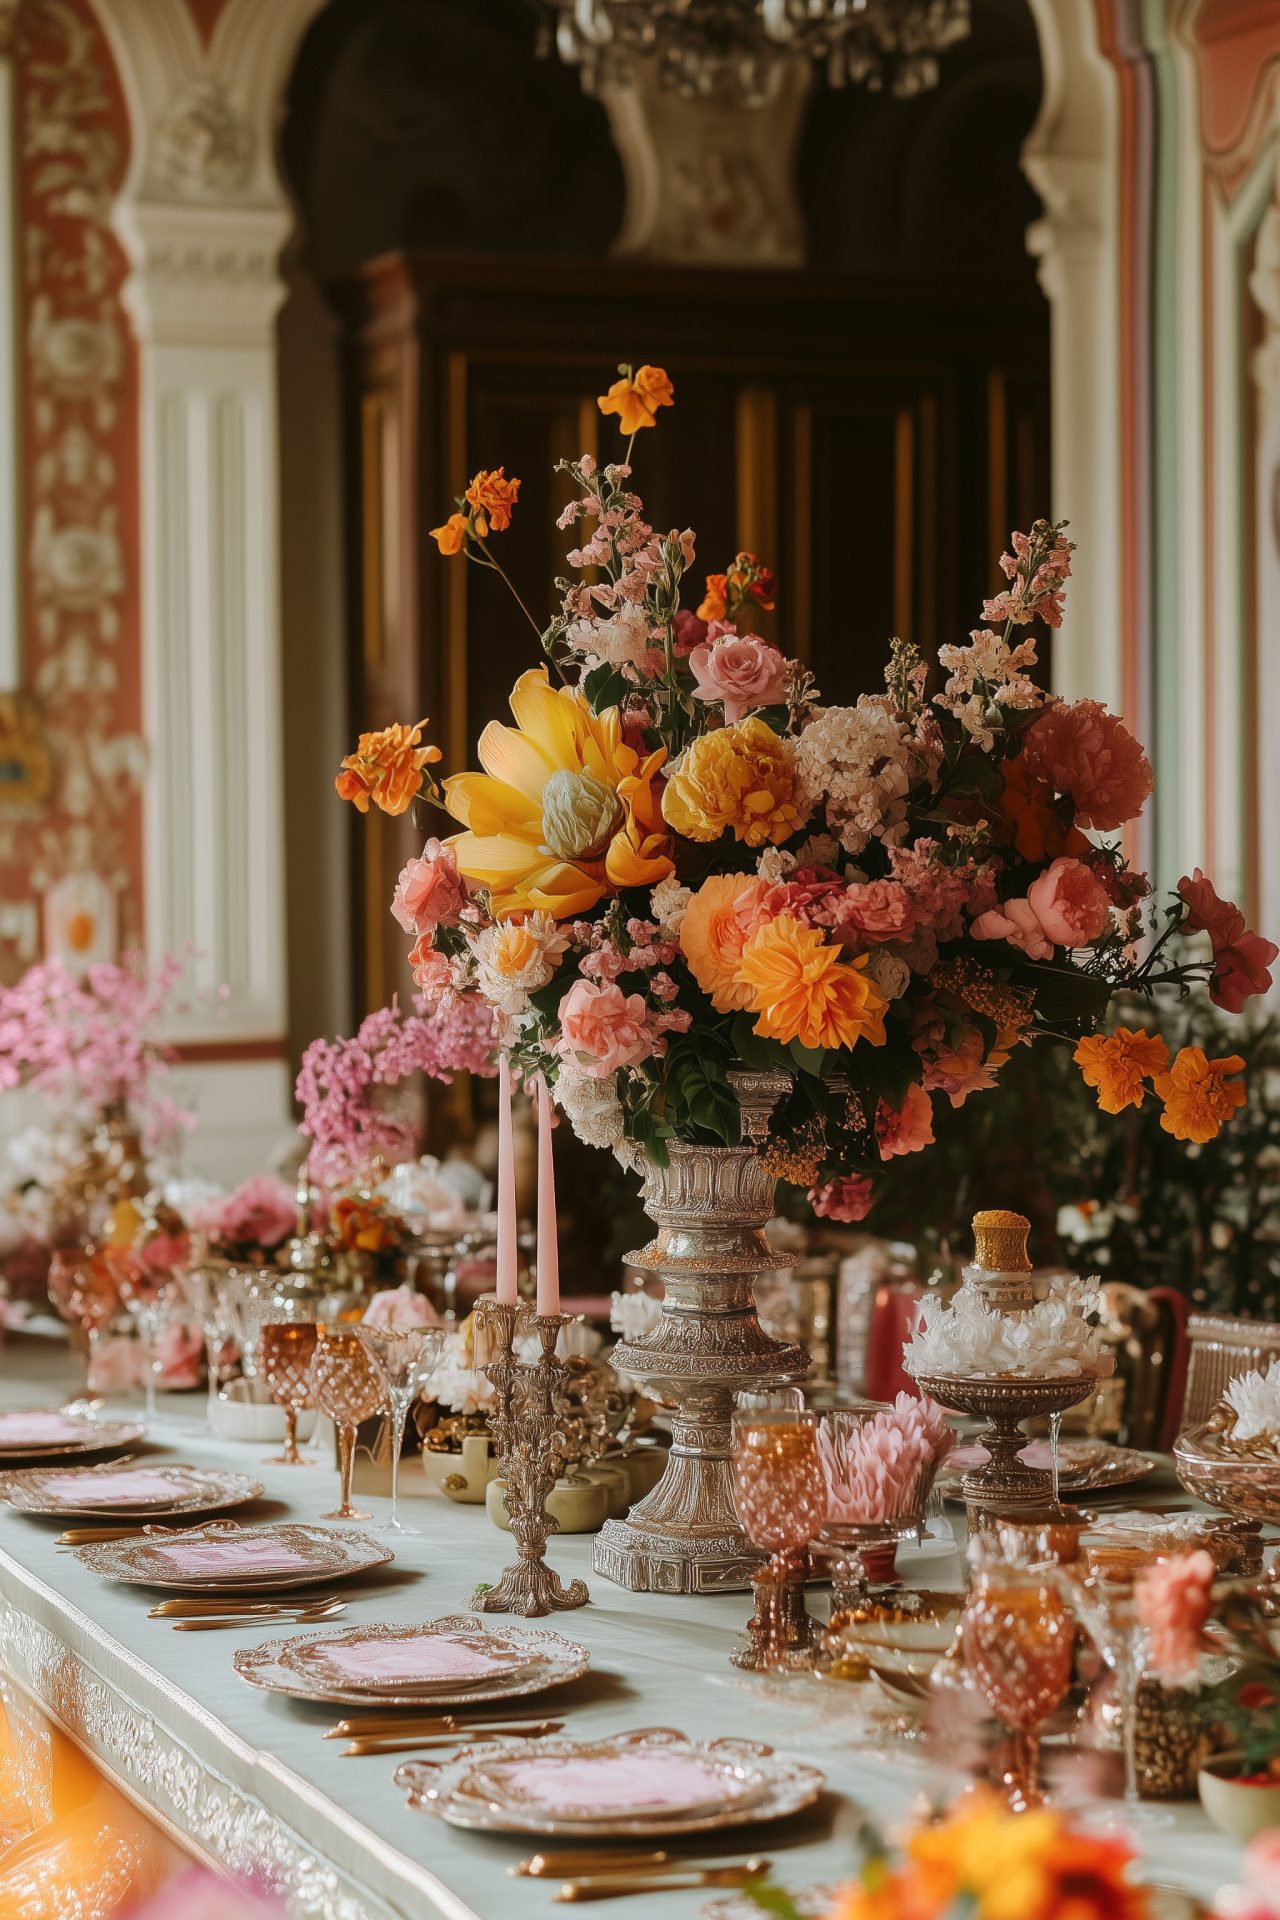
top-left (662, 714), bottom-right (808, 847)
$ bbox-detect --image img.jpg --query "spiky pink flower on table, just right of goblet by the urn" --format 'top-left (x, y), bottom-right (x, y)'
top-left (818, 1394), bottom-right (956, 1523)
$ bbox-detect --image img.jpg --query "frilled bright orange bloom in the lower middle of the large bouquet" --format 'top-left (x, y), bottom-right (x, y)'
top-left (739, 914), bottom-right (889, 1046)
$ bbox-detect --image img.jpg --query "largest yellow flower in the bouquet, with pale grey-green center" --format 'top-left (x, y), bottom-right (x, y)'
top-left (445, 666), bottom-right (674, 920)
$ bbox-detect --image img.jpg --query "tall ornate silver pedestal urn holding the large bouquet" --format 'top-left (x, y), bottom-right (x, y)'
top-left (595, 1069), bottom-right (810, 1594)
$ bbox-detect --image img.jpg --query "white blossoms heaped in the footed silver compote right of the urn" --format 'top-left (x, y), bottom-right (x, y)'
top-left (904, 1275), bottom-right (1115, 1380)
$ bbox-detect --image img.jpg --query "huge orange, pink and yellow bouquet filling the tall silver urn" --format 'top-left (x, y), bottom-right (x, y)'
top-left (338, 367), bottom-right (1276, 1219)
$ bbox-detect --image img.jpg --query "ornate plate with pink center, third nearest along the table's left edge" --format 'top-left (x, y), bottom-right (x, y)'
top-left (79, 1521), bottom-right (393, 1594)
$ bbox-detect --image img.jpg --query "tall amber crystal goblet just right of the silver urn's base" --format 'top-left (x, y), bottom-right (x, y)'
top-left (731, 1405), bottom-right (827, 1672)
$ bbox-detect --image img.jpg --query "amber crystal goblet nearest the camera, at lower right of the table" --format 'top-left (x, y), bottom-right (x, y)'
top-left (960, 1565), bottom-right (1075, 1812)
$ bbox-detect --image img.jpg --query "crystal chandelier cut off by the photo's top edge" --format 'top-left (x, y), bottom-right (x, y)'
top-left (533, 0), bottom-right (969, 106)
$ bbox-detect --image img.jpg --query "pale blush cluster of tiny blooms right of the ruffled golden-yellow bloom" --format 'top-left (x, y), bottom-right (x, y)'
top-left (794, 703), bottom-right (919, 852)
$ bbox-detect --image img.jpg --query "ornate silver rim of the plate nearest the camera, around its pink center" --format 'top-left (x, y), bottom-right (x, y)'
top-left (393, 1726), bottom-right (825, 1839)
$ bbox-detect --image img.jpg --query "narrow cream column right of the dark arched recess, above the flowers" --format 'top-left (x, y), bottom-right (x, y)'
top-left (1023, 0), bottom-right (1123, 712)
